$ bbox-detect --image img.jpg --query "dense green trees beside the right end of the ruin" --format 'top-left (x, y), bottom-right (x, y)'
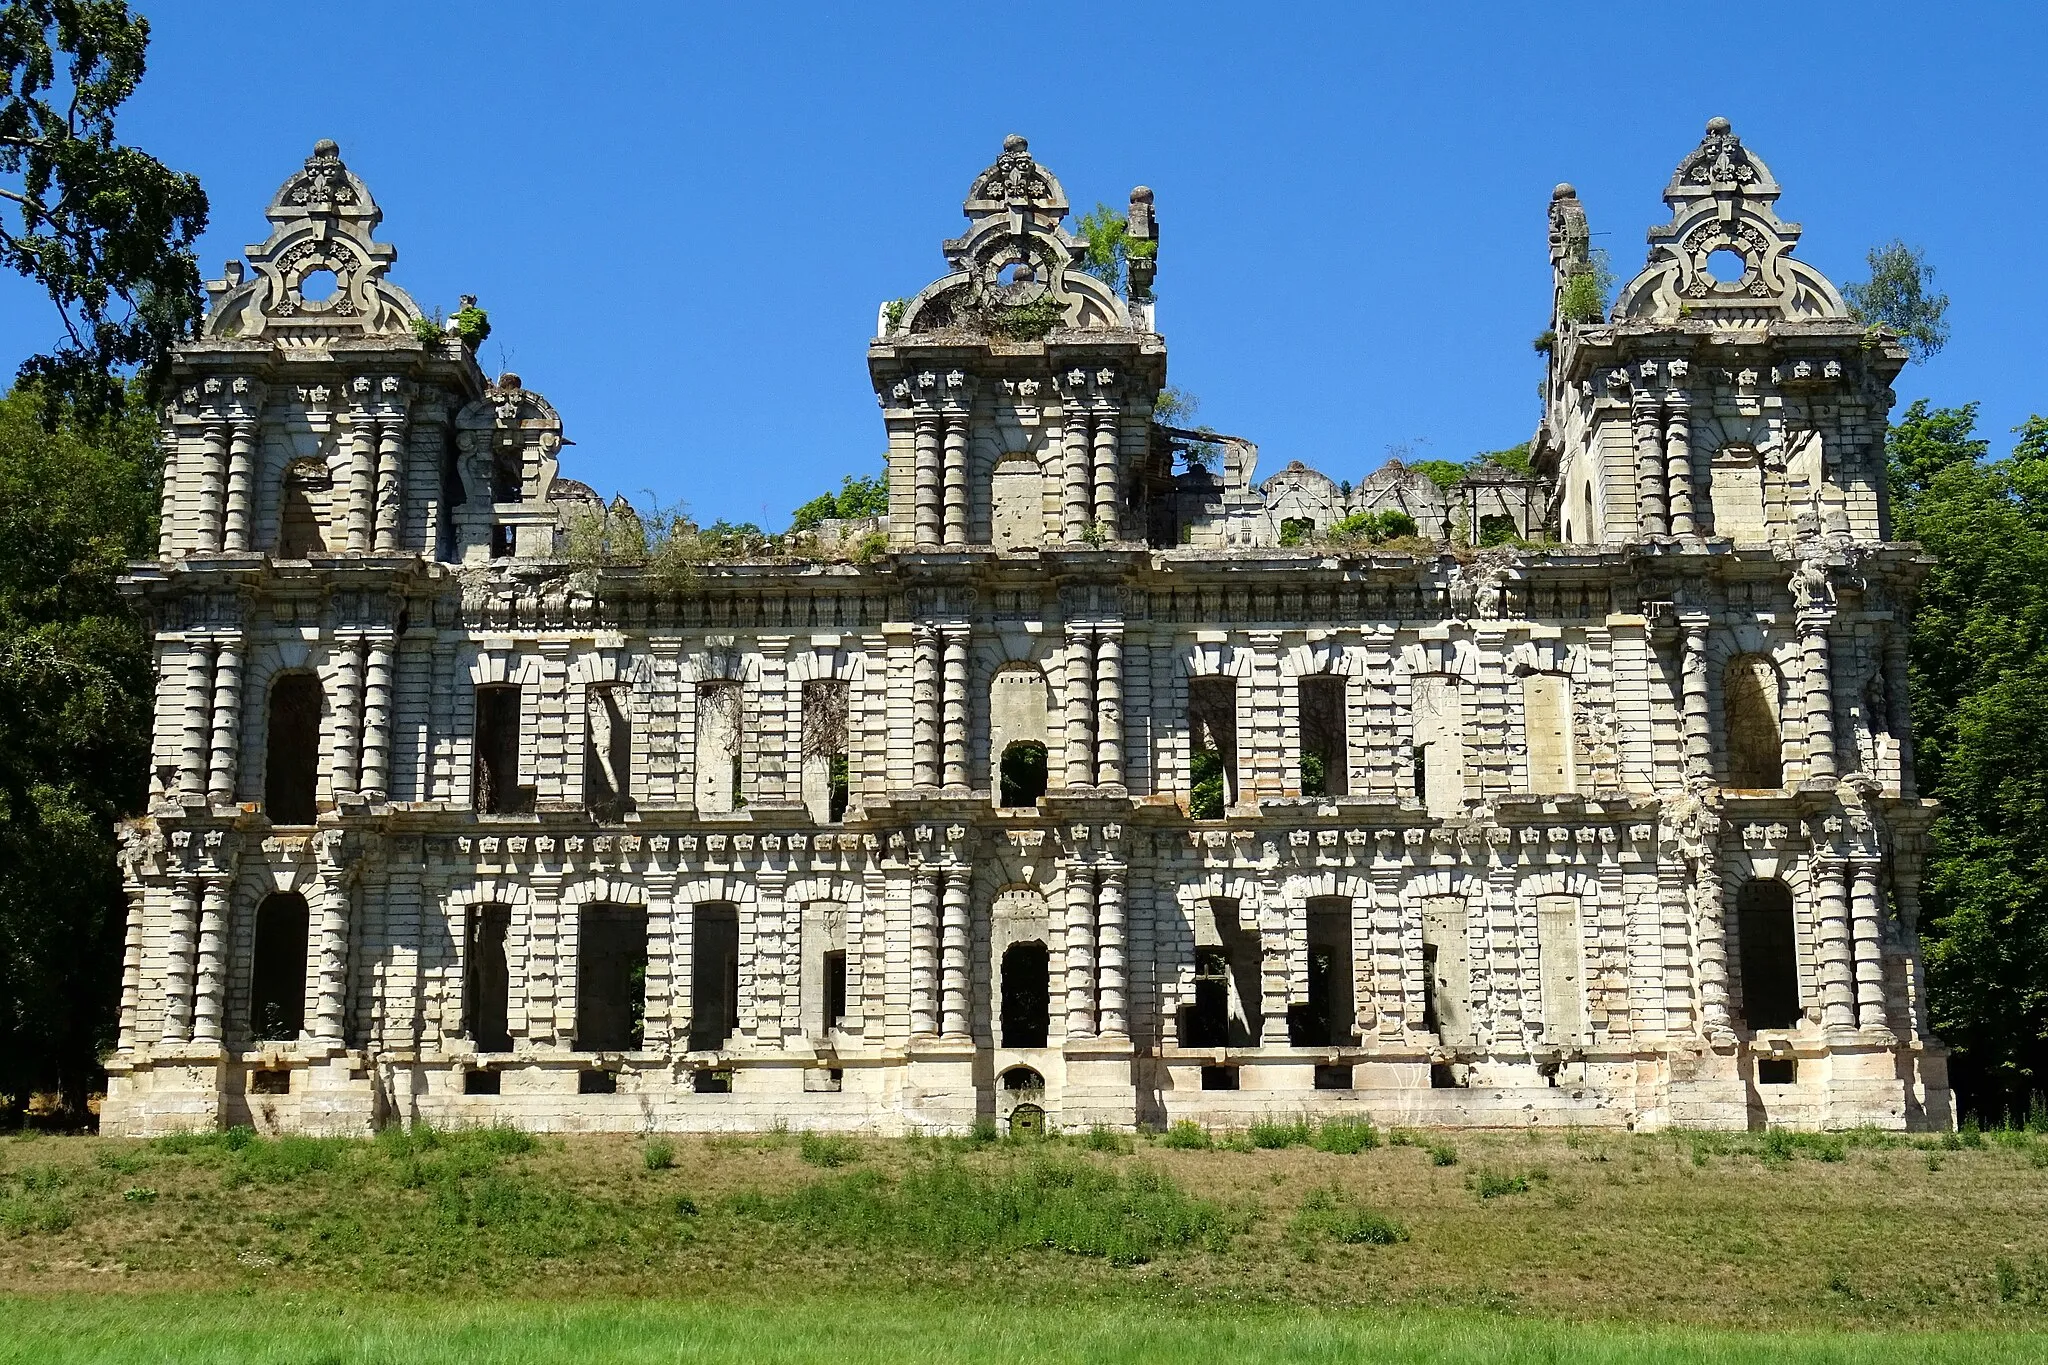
top-left (1886, 401), bottom-right (2048, 1119)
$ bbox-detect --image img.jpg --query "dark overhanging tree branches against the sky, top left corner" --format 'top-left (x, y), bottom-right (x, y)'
top-left (0, 0), bottom-right (207, 424)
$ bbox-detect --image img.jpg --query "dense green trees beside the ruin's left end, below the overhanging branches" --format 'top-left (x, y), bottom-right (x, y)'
top-left (0, 389), bottom-right (158, 1113)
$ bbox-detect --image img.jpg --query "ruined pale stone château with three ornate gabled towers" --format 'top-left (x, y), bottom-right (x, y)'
top-left (102, 121), bottom-right (1952, 1134)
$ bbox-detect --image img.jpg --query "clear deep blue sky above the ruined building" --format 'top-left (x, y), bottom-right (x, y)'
top-left (0, 0), bottom-right (2048, 528)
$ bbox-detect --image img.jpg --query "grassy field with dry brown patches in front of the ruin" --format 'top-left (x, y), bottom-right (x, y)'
top-left (0, 1119), bottom-right (2048, 1365)
